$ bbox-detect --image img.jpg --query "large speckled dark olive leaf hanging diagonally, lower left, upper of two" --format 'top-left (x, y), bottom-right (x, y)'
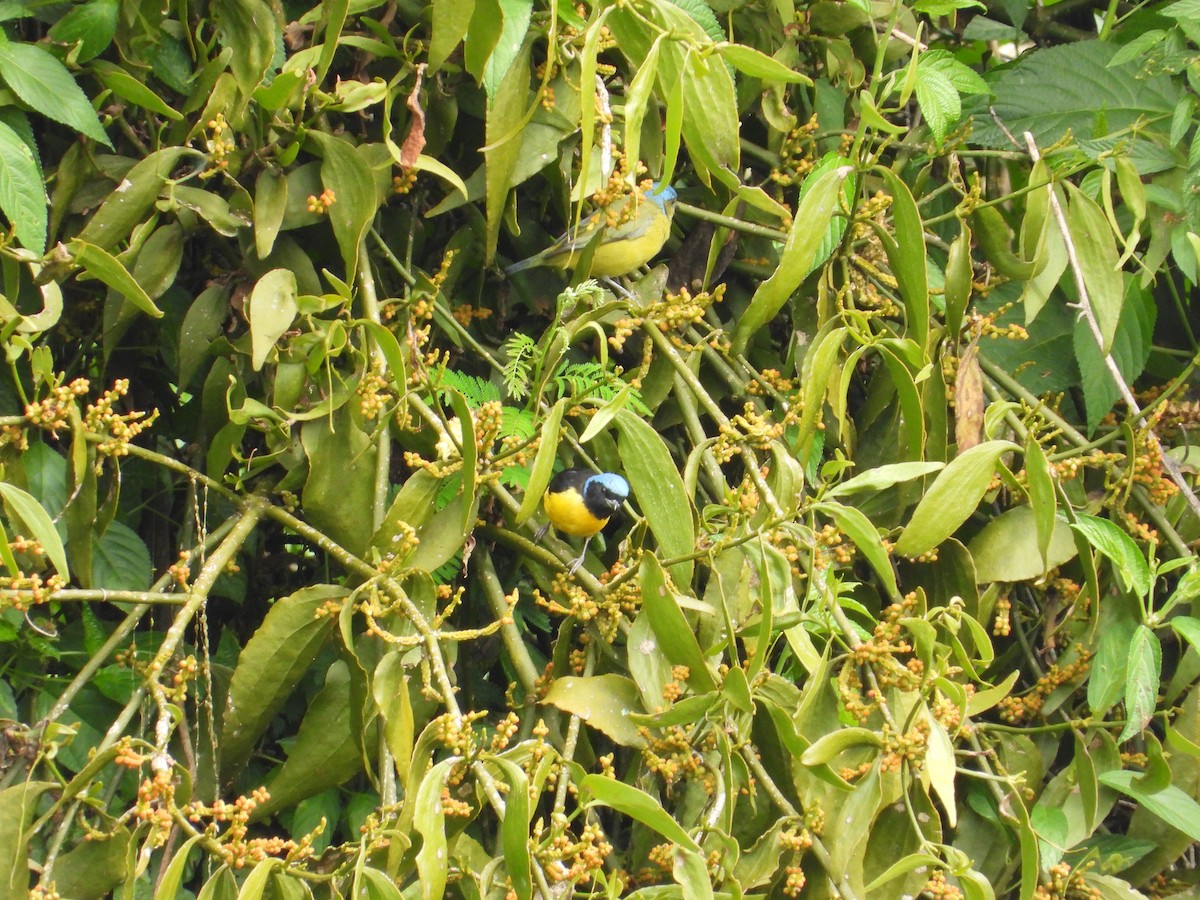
top-left (220, 584), bottom-right (349, 779)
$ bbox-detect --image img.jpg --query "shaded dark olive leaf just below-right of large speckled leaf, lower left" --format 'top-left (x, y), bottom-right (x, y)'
top-left (252, 660), bottom-right (364, 820)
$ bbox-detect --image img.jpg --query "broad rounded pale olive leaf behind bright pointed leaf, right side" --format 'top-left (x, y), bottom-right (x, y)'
top-left (967, 506), bottom-right (1076, 584)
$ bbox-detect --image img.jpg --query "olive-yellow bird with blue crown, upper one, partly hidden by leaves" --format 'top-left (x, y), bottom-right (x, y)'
top-left (504, 181), bottom-right (678, 278)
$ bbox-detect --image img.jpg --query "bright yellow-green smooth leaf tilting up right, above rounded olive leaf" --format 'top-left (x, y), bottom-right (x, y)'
top-left (895, 440), bottom-right (1018, 557)
